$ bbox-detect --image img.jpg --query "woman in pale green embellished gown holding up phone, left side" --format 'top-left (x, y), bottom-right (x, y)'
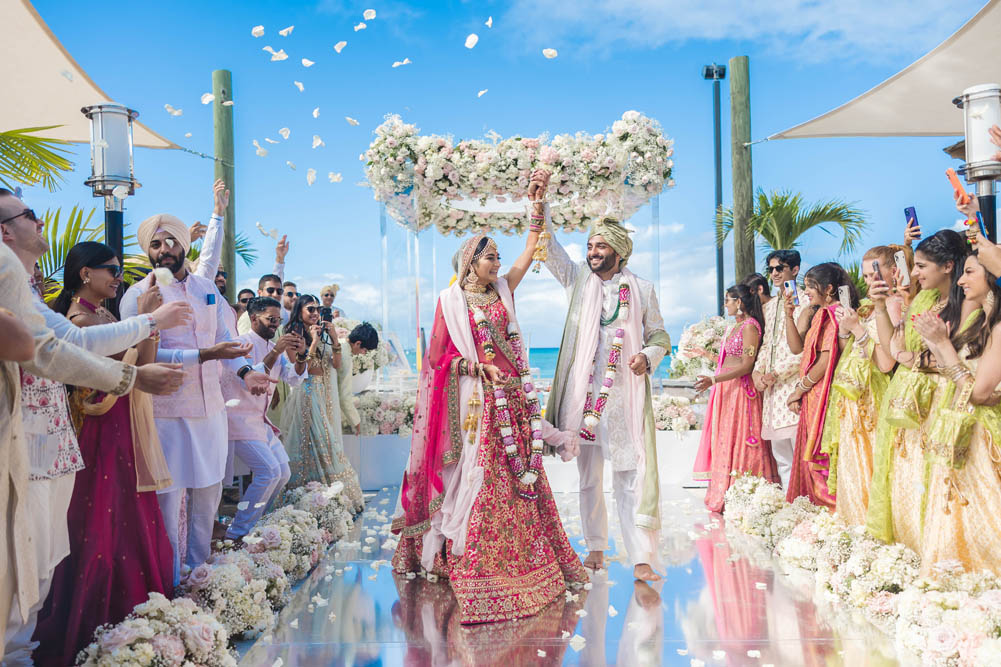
top-left (281, 294), bottom-right (364, 512)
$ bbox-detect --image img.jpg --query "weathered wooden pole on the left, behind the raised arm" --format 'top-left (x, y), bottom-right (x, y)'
top-left (212, 69), bottom-right (236, 303)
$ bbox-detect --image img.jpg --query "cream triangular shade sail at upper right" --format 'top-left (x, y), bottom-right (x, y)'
top-left (768, 0), bottom-right (1001, 139)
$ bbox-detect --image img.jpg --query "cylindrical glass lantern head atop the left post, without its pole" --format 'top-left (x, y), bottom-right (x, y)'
top-left (80, 103), bottom-right (139, 199)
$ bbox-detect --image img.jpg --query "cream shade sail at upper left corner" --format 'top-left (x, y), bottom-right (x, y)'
top-left (0, 0), bottom-right (178, 148)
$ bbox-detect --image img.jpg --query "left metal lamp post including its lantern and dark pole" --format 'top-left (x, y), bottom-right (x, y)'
top-left (80, 103), bottom-right (139, 255)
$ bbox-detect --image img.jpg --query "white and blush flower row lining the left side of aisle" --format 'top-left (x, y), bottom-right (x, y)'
top-left (77, 482), bottom-right (353, 667)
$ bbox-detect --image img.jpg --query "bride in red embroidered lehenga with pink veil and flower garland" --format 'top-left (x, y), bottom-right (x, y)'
top-left (392, 227), bottom-right (588, 624)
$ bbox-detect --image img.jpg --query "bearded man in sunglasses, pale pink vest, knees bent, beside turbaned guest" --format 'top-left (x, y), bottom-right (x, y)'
top-left (222, 296), bottom-right (306, 540)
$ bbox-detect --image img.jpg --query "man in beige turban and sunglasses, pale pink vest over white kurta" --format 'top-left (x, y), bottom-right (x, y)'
top-left (121, 200), bottom-right (271, 584)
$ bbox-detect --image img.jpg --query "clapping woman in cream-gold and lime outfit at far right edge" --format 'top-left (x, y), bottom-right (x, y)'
top-left (914, 255), bottom-right (1001, 574)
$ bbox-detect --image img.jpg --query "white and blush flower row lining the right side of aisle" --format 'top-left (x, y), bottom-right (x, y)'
top-left (726, 476), bottom-right (1001, 667)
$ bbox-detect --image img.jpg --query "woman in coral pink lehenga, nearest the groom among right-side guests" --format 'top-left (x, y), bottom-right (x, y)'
top-left (693, 284), bottom-right (779, 512)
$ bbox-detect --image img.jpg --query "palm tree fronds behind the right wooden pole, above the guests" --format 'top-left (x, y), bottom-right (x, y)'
top-left (716, 190), bottom-right (869, 254)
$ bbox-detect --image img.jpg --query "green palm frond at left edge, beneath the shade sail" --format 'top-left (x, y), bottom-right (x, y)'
top-left (0, 125), bottom-right (73, 192)
